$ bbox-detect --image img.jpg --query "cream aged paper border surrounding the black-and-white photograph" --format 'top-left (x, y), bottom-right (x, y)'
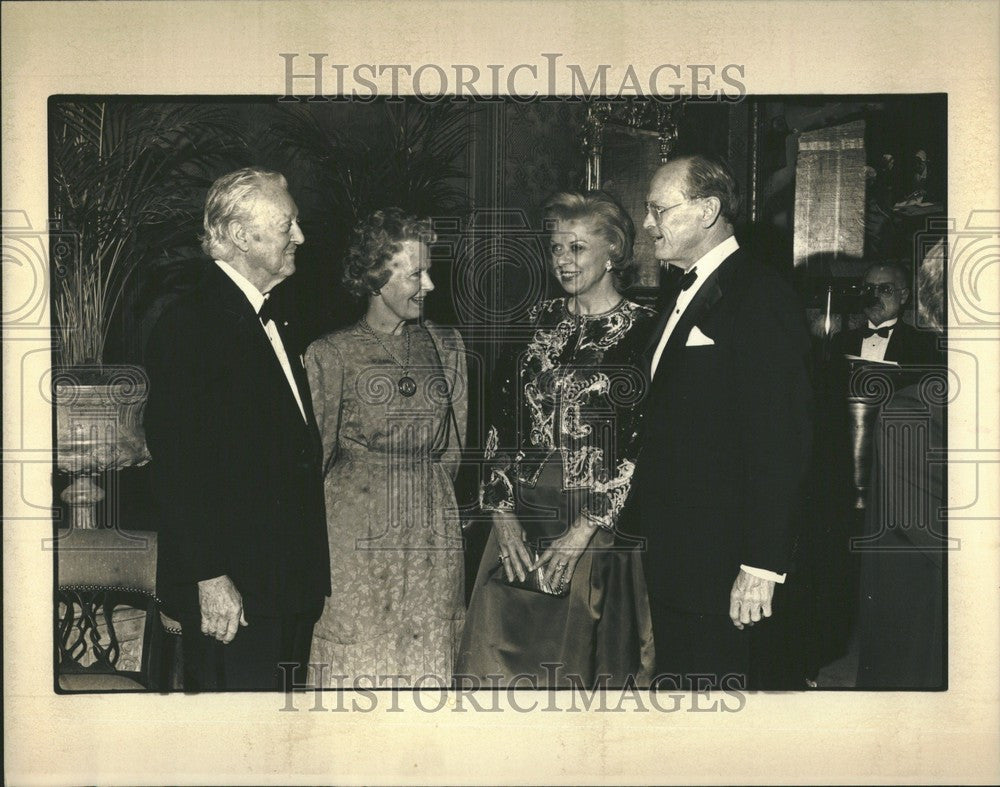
top-left (2, 2), bottom-right (1000, 785)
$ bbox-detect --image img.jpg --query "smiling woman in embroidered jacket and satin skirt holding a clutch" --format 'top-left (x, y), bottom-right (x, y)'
top-left (456, 192), bottom-right (654, 687)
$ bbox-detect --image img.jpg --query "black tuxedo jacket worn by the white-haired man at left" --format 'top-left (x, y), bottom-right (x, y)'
top-left (145, 263), bottom-right (330, 623)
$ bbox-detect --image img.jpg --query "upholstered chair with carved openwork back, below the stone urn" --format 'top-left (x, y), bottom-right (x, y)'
top-left (55, 529), bottom-right (162, 692)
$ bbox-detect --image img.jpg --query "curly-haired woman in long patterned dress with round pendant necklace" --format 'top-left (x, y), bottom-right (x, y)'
top-left (305, 208), bottom-right (466, 687)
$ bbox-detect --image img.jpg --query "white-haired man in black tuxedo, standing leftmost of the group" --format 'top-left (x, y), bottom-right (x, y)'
top-left (146, 168), bottom-right (330, 691)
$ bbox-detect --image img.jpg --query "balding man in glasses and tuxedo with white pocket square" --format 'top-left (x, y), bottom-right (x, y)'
top-left (622, 156), bottom-right (811, 688)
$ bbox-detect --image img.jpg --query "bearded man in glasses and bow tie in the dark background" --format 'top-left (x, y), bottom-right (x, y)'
top-left (832, 262), bottom-right (940, 366)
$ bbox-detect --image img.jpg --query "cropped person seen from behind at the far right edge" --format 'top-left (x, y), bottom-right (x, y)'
top-left (852, 244), bottom-right (954, 689)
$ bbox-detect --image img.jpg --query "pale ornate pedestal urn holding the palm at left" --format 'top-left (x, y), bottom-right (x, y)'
top-left (52, 365), bottom-right (150, 529)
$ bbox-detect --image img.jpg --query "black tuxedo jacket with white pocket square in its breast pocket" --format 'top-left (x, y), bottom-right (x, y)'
top-left (620, 249), bottom-right (812, 619)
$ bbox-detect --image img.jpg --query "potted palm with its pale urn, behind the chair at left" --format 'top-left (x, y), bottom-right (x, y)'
top-left (49, 99), bottom-right (242, 527)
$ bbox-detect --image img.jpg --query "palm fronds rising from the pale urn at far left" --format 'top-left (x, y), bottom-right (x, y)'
top-left (50, 99), bottom-right (246, 364)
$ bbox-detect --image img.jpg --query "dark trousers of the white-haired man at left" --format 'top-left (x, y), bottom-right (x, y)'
top-left (179, 615), bottom-right (318, 692)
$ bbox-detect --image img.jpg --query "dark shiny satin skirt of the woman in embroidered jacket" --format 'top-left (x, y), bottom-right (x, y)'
top-left (455, 460), bottom-right (655, 688)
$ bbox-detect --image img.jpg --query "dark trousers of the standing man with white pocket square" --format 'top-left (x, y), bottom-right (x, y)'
top-left (652, 607), bottom-right (750, 689)
